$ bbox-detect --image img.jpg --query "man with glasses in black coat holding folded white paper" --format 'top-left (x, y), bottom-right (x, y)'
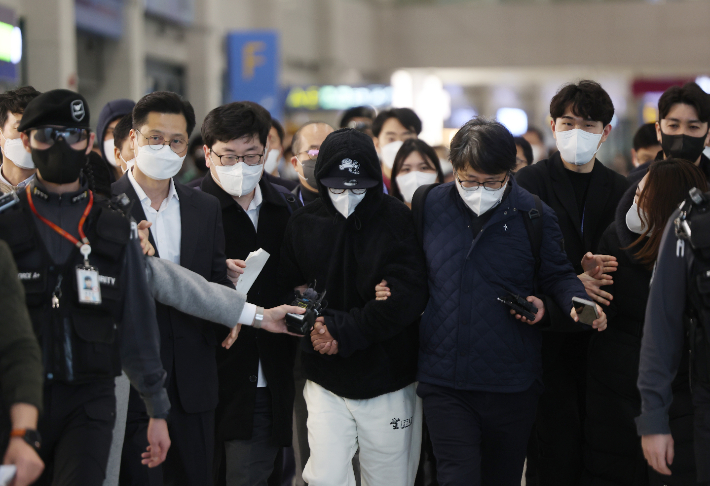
top-left (200, 101), bottom-right (301, 486)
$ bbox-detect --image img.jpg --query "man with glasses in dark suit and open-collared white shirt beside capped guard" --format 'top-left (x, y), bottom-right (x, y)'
top-left (112, 91), bottom-right (232, 486)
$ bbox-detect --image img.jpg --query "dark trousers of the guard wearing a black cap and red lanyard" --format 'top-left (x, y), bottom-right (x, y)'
top-left (34, 378), bottom-right (116, 486)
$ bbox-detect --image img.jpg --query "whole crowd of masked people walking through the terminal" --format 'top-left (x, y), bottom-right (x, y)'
top-left (0, 80), bottom-right (710, 486)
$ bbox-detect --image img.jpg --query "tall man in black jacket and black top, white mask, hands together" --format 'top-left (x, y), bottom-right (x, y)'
top-left (516, 80), bottom-right (628, 486)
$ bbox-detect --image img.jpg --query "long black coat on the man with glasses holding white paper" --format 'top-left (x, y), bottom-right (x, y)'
top-left (201, 176), bottom-right (298, 447)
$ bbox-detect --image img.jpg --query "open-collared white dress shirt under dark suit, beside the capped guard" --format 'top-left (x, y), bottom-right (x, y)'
top-left (128, 171), bottom-right (182, 265)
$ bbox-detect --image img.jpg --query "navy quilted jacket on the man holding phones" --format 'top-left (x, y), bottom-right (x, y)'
top-left (417, 179), bottom-right (587, 393)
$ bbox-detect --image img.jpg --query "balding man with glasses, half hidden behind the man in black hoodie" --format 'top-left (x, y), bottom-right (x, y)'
top-left (291, 122), bottom-right (333, 204)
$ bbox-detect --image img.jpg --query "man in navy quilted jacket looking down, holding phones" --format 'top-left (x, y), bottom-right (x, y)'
top-left (414, 118), bottom-right (606, 486)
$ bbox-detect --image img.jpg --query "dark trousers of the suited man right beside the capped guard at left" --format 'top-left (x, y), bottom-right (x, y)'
top-left (120, 368), bottom-right (214, 486)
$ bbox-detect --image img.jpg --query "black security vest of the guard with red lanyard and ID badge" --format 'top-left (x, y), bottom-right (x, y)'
top-left (0, 191), bottom-right (131, 384)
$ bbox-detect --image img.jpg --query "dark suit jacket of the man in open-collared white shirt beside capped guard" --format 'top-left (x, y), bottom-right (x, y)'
top-left (111, 175), bottom-right (234, 413)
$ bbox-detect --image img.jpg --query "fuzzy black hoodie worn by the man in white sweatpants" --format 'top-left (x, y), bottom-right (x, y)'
top-left (281, 141), bottom-right (428, 399)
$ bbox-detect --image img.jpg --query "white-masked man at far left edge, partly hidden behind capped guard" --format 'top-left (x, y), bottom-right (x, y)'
top-left (0, 86), bottom-right (40, 194)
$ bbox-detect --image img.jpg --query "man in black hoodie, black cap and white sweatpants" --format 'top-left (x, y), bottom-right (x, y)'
top-left (281, 129), bottom-right (428, 486)
